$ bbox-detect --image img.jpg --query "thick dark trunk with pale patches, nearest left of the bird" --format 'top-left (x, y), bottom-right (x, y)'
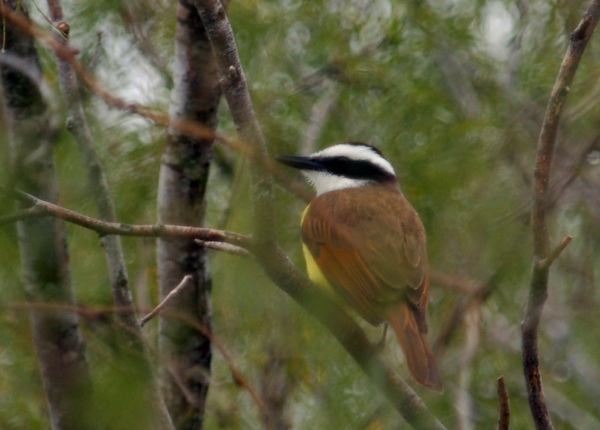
top-left (158, 0), bottom-right (221, 429)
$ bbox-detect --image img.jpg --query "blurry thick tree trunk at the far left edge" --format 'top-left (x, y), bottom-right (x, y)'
top-left (0, 0), bottom-right (94, 430)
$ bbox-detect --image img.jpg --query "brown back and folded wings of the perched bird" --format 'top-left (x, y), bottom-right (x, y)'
top-left (302, 186), bottom-right (428, 332)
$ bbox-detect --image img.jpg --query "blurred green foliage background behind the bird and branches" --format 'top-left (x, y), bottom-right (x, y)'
top-left (0, 0), bottom-right (600, 430)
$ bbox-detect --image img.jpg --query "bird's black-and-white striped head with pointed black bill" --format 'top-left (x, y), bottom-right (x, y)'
top-left (276, 142), bottom-right (396, 196)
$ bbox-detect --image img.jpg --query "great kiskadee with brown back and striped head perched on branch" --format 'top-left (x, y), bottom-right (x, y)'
top-left (277, 142), bottom-right (443, 392)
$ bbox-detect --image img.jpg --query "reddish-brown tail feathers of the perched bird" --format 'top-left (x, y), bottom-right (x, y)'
top-left (386, 302), bottom-right (444, 393)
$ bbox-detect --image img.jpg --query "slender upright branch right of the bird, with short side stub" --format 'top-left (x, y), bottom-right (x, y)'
top-left (521, 0), bottom-right (600, 430)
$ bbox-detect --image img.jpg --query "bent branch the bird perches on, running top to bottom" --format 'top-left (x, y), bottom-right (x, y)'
top-left (195, 0), bottom-right (444, 429)
